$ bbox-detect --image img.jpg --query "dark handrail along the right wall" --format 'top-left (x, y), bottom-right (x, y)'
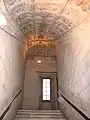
top-left (58, 91), bottom-right (90, 120)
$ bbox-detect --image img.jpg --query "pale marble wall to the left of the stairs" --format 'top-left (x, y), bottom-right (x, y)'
top-left (0, 23), bottom-right (24, 120)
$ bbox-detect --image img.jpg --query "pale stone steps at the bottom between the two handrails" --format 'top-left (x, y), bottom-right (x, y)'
top-left (14, 110), bottom-right (66, 120)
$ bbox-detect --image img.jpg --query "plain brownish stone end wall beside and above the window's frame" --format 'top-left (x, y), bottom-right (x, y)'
top-left (23, 57), bottom-right (56, 109)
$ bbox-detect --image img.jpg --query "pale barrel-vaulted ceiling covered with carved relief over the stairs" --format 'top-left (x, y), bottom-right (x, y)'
top-left (3, 0), bottom-right (89, 40)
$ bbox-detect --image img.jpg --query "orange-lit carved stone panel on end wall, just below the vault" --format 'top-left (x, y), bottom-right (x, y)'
top-left (27, 39), bottom-right (56, 57)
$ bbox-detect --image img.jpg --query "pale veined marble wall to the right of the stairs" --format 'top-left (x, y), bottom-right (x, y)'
top-left (57, 18), bottom-right (90, 120)
